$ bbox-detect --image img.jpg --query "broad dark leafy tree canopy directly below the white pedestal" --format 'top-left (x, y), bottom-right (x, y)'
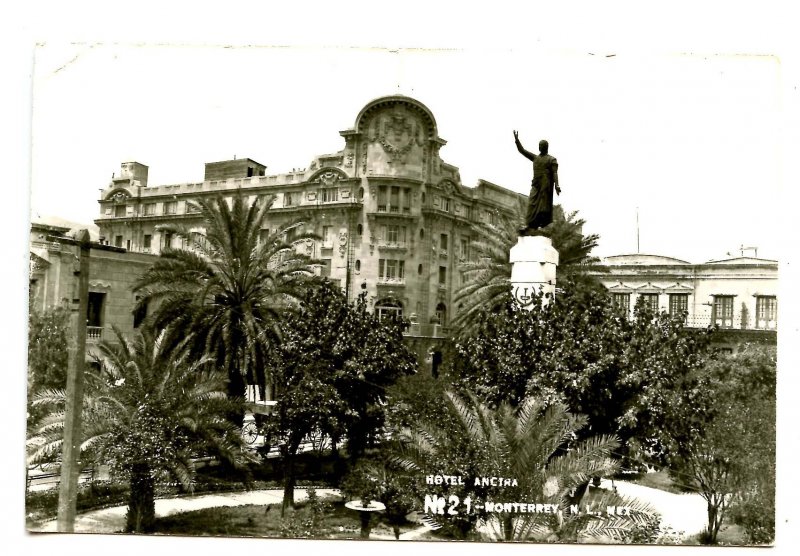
top-left (449, 289), bottom-right (710, 460)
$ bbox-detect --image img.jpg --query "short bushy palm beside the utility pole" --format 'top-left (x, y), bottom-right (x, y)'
top-left (28, 329), bottom-right (245, 533)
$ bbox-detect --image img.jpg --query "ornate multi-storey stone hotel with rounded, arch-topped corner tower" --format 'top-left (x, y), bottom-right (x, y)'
top-left (95, 96), bottom-right (521, 364)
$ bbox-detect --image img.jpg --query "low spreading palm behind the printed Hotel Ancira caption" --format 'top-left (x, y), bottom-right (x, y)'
top-left (395, 392), bottom-right (651, 542)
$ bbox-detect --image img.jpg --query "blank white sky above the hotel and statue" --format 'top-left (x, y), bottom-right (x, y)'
top-left (31, 43), bottom-right (783, 262)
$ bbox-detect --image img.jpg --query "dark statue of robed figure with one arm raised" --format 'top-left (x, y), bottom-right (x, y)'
top-left (514, 130), bottom-right (561, 236)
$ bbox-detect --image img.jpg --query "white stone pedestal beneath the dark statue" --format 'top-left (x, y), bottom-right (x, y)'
top-left (510, 236), bottom-right (558, 310)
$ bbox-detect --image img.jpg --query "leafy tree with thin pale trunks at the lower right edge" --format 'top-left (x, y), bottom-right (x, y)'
top-left (664, 346), bottom-right (776, 544)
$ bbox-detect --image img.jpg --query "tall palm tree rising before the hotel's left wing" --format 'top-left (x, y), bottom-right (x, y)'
top-left (134, 192), bottom-right (314, 410)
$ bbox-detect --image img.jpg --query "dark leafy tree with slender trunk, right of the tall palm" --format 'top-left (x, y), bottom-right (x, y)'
top-left (267, 280), bottom-right (416, 511)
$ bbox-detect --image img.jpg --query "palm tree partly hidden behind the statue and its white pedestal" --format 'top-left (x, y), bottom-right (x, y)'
top-left (452, 202), bottom-right (600, 338)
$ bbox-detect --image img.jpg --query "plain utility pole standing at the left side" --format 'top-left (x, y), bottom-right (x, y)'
top-left (58, 230), bottom-right (91, 533)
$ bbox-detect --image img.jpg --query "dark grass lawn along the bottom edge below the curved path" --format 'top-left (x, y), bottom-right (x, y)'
top-left (155, 501), bottom-right (420, 539)
